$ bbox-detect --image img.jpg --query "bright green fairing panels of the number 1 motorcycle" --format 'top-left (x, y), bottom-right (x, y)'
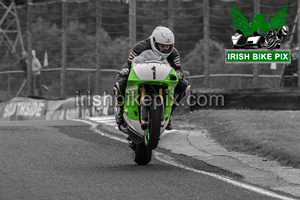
top-left (124, 68), bottom-right (178, 121)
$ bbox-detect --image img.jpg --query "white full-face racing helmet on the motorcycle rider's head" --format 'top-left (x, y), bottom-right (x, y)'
top-left (150, 26), bottom-right (175, 59)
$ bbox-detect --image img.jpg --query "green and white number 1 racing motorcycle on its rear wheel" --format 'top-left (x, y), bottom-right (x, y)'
top-left (119, 51), bottom-right (178, 165)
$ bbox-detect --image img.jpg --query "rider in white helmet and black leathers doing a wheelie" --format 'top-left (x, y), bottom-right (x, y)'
top-left (114, 26), bottom-right (190, 130)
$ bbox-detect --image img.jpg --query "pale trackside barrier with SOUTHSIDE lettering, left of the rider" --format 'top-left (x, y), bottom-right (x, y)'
top-left (0, 97), bottom-right (113, 121)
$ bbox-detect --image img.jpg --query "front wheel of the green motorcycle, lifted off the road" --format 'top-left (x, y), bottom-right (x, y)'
top-left (145, 98), bottom-right (163, 150)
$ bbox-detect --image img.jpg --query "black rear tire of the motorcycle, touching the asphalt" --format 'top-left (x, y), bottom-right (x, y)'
top-left (133, 143), bottom-right (152, 165)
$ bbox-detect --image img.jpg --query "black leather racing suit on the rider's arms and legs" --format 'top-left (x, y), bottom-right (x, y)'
top-left (117, 38), bottom-right (189, 103)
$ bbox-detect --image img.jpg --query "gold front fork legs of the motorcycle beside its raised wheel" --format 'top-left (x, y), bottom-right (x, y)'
top-left (140, 87), bottom-right (165, 130)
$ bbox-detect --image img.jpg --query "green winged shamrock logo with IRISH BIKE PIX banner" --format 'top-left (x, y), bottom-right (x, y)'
top-left (225, 5), bottom-right (291, 63)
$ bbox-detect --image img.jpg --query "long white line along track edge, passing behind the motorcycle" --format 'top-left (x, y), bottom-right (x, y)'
top-left (73, 119), bottom-right (296, 200)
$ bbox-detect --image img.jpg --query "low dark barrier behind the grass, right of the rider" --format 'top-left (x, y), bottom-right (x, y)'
top-left (190, 90), bottom-right (300, 111)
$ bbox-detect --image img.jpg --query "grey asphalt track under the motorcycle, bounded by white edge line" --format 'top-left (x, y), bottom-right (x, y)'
top-left (0, 121), bottom-right (288, 200)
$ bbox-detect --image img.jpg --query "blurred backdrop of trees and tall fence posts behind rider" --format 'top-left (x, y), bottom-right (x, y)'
top-left (0, 0), bottom-right (300, 101)
